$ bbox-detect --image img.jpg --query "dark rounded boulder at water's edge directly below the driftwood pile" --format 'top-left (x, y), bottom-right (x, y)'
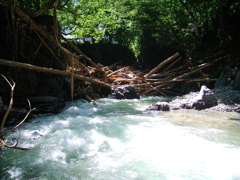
top-left (109, 86), bottom-right (140, 99)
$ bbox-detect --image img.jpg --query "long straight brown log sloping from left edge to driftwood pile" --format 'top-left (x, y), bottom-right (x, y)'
top-left (0, 59), bottom-right (110, 88)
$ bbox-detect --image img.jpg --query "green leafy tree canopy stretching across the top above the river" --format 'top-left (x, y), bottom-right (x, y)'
top-left (17, 0), bottom-right (240, 63)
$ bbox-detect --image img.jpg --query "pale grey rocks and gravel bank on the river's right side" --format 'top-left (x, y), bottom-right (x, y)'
top-left (147, 86), bottom-right (240, 113)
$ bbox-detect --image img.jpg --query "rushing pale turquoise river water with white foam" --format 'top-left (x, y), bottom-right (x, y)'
top-left (0, 97), bottom-right (240, 180)
